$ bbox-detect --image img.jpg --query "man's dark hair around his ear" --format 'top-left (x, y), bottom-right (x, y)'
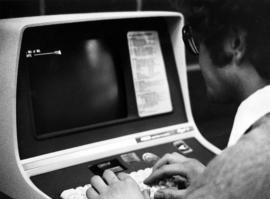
top-left (186, 0), bottom-right (270, 79)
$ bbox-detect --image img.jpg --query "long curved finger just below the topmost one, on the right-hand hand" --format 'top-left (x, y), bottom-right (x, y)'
top-left (144, 164), bottom-right (189, 184)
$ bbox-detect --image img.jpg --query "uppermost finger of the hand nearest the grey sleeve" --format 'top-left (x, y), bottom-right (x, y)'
top-left (153, 152), bottom-right (187, 170)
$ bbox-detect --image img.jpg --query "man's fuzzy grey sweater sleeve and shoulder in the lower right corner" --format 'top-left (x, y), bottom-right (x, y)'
top-left (187, 114), bottom-right (270, 199)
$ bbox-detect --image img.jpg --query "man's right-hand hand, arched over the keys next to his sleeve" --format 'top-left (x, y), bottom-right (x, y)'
top-left (144, 153), bottom-right (205, 199)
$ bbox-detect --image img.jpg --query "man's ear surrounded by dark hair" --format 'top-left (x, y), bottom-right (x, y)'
top-left (224, 28), bottom-right (246, 64)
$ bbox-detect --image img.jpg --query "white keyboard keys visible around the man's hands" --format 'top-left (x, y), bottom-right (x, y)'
top-left (60, 168), bottom-right (157, 199)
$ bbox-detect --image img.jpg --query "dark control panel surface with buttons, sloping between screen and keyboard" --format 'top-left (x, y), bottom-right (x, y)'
top-left (31, 138), bottom-right (215, 198)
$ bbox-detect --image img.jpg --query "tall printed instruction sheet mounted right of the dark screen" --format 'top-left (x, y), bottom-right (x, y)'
top-left (127, 31), bottom-right (173, 117)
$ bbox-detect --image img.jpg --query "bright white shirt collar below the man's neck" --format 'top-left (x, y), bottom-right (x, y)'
top-left (228, 85), bottom-right (270, 147)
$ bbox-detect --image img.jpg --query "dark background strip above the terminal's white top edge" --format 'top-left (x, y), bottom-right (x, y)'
top-left (0, 0), bottom-right (185, 18)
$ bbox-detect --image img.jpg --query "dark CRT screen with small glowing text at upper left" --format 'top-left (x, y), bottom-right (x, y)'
top-left (29, 39), bottom-right (126, 136)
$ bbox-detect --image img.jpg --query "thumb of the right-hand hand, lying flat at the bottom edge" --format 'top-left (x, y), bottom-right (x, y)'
top-left (154, 189), bottom-right (186, 199)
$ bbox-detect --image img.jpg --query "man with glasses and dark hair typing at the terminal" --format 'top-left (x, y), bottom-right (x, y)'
top-left (87, 0), bottom-right (270, 199)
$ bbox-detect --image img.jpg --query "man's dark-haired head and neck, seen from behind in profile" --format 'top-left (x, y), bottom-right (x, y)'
top-left (187, 0), bottom-right (270, 101)
